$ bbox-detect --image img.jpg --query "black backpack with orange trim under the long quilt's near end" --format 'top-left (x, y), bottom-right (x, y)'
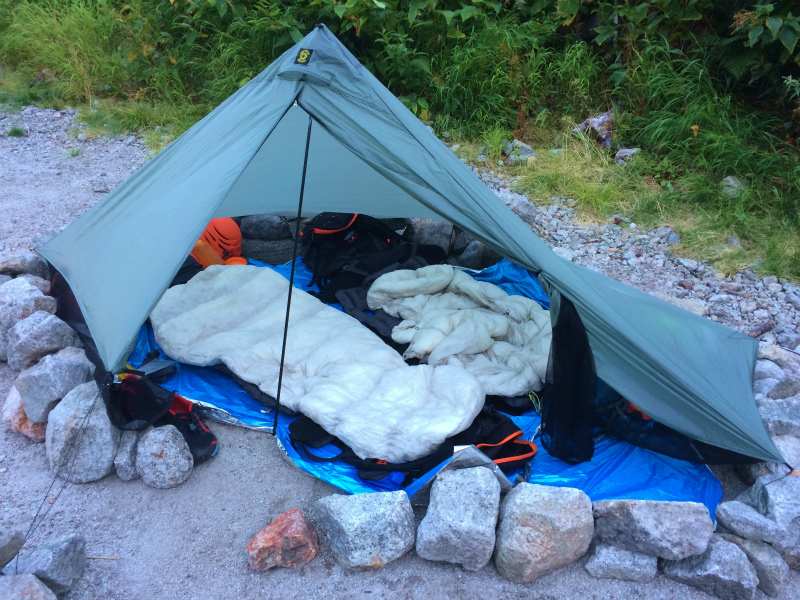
top-left (289, 407), bottom-right (537, 483)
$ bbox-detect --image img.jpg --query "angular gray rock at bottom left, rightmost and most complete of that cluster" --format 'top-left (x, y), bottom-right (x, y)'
top-left (15, 533), bottom-right (86, 594)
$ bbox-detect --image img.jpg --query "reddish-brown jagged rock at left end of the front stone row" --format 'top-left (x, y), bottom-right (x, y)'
top-left (247, 508), bottom-right (319, 571)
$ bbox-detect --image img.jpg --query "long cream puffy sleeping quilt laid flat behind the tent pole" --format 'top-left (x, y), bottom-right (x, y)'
top-left (150, 265), bottom-right (484, 462)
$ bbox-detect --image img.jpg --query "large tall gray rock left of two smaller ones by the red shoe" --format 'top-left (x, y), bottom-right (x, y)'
top-left (45, 381), bottom-right (120, 483)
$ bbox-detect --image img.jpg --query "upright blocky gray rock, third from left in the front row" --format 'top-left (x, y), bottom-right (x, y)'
top-left (417, 467), bottom-right (500, 571)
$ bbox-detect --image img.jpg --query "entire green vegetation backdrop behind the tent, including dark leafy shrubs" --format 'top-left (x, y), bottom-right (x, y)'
top-left (0, 0), bottom-right (800, 278)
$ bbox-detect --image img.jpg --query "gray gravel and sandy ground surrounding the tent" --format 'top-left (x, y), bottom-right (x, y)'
top-left (0, 108), bottom-right (800, 600)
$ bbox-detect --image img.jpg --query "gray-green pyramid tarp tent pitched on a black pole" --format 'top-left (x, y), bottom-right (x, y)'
top-left (38, 25), bottom-right (783, 462)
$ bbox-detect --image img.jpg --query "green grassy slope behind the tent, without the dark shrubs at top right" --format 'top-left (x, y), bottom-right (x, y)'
top-left (0, 0), bottom-right (800, 280)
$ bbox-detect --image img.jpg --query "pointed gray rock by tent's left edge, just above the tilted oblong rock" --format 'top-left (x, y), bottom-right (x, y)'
top-left (6, 314), bottom-right (83, 371)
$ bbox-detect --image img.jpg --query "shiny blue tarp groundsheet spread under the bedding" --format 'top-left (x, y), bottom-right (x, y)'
top-left (128, 258), bottom-right (722, 518)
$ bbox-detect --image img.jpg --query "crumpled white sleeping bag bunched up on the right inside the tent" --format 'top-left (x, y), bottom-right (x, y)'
top-left (367, 265), bottom-right (552, 396)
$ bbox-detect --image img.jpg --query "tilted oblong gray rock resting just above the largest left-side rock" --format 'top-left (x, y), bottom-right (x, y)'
top-left (16, 347), bottom-right (94, 423)
